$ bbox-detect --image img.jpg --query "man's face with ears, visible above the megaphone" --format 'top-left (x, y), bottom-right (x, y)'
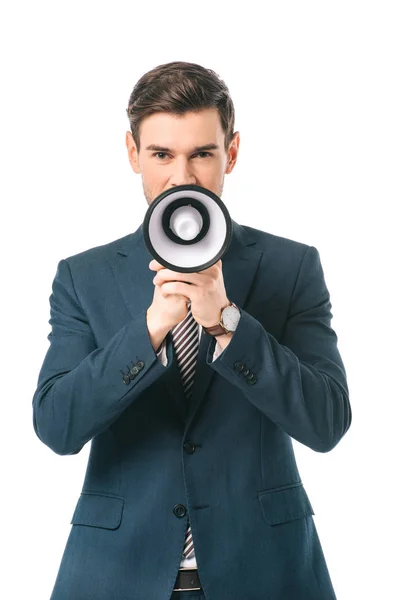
top-left (126, 108), bottom-right (240, 205)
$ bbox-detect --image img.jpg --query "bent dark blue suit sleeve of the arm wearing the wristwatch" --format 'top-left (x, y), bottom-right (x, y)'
top-left (207, 246), bottom-right (352, 452)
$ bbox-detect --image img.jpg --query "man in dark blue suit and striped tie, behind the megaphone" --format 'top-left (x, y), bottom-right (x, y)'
top-left (33, 62), bottom-right (351, 600)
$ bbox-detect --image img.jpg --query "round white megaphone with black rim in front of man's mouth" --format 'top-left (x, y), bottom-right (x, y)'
top-left (143, 185), bottom-right (233, 273)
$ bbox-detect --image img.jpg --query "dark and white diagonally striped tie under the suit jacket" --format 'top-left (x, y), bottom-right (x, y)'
top-left (171, 302), bottom-right (199, 558)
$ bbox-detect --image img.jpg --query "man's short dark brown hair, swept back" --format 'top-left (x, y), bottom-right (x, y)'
top-left (126, 61), bottom-right (235, 152)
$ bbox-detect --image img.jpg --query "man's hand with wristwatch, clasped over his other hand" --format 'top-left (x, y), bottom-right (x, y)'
top-left (149, 259), bottom-right (230, 327)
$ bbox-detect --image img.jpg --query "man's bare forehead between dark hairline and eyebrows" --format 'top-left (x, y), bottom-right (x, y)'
top-left (140, 108), bottom-right (224, 145)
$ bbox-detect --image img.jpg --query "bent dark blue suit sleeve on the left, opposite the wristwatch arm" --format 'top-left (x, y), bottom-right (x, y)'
top-left (32, 260), bottom-right (173, 454)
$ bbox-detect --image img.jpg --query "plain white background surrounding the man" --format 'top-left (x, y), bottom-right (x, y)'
top-left (0, 0), bottom-right (400, 600)
